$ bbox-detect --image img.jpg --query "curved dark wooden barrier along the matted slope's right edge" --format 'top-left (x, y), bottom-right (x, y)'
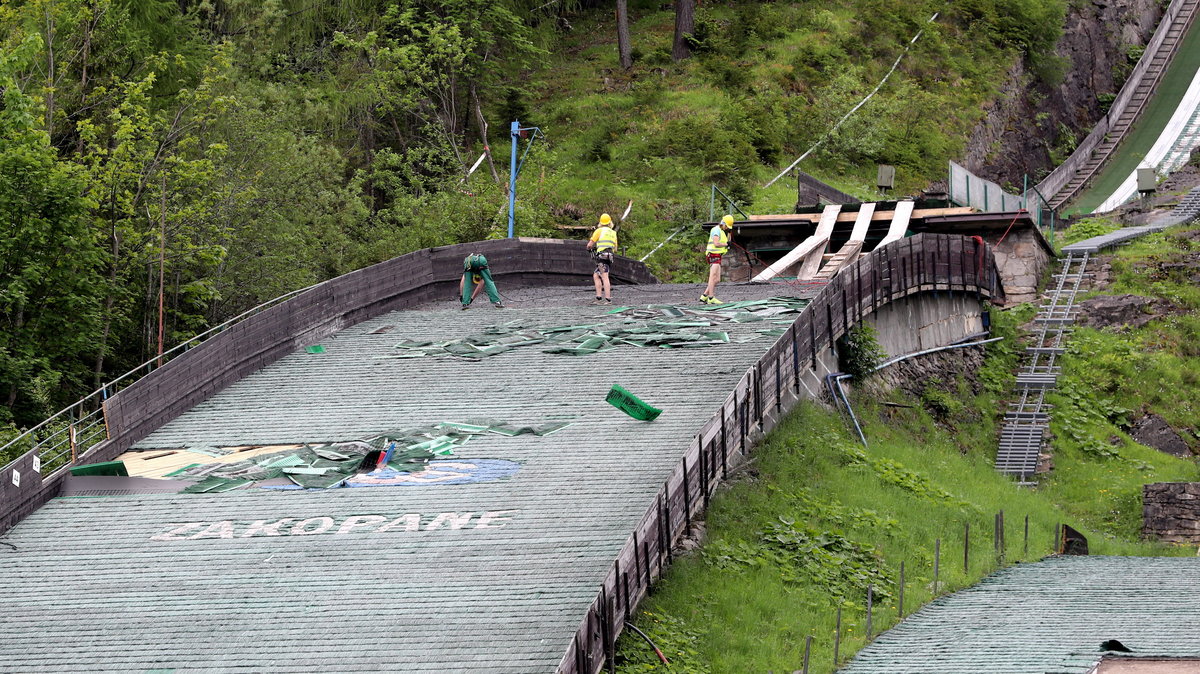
top-left (558, 234), bottom-right (1003, 674)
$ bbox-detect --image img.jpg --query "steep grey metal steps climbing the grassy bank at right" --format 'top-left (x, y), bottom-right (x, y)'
top-left (996, 253), bottom-right (1090, 485)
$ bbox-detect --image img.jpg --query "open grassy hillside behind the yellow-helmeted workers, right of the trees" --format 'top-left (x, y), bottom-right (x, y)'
top-left (509, 1), bottom-right (1062, 281)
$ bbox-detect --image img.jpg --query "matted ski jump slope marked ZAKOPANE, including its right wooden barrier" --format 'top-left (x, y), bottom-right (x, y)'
top-left (0, 235), bottom-right (1002, 672)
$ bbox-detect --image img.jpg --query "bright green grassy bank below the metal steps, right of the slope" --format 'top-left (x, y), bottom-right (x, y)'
top-left (619, 223), bottom-right (1200, 673)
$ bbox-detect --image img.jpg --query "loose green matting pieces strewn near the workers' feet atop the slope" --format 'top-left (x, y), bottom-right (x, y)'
top-left (377, 297), bottom-right (809, 360)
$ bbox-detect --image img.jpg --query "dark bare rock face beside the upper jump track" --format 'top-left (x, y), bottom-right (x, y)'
top-left (964, 0), bottom-right (1163, 189)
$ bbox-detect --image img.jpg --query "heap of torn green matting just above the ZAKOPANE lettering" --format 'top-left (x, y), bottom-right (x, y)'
top-left (167, 420), bottom-right (571, 494)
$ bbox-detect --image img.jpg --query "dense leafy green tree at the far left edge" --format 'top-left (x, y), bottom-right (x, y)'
top-left (0, 36), bottom-right (103, 425)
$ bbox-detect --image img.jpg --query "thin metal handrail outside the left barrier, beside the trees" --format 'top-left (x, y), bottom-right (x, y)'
top-left (0, 281), bottom-right (328, 470)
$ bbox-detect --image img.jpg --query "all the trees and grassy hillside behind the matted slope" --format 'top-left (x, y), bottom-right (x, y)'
top-left (0, 0), bottom-right (1066, 446)
